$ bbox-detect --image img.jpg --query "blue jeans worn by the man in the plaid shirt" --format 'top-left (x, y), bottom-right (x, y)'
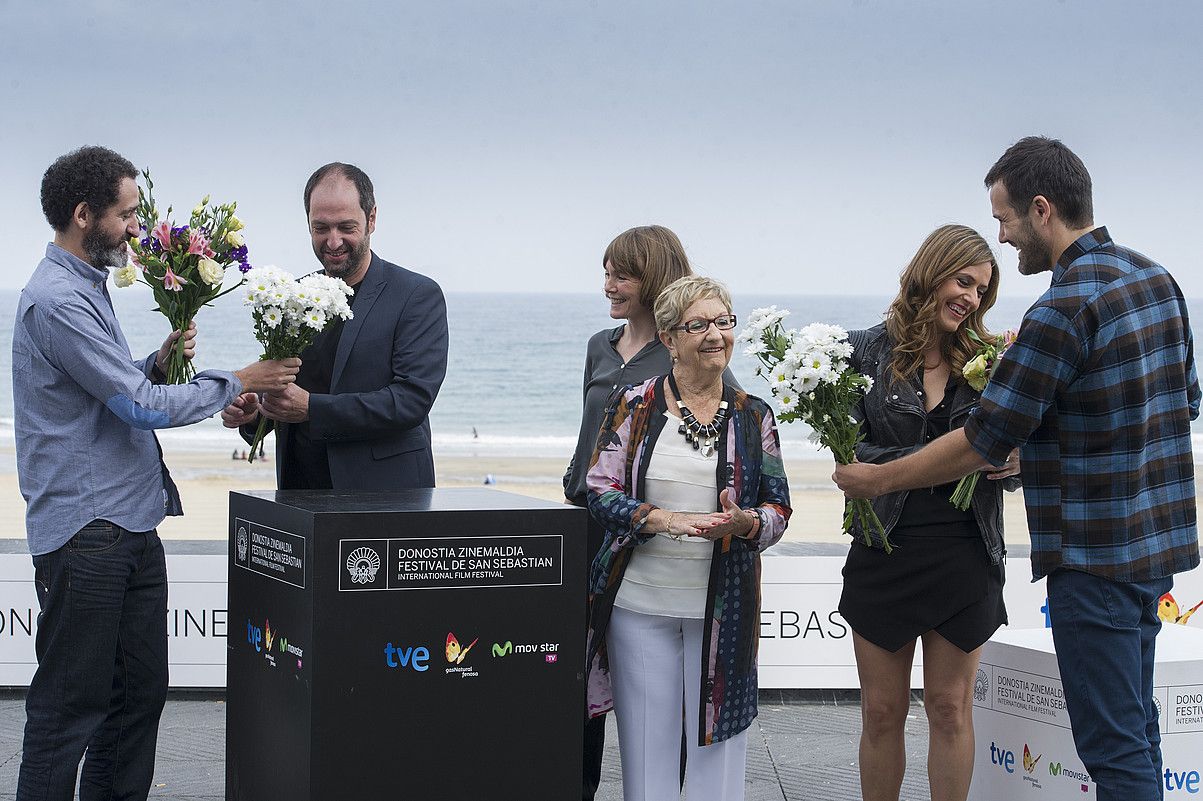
top-left (1048, 569), bottom-right (1174, 801)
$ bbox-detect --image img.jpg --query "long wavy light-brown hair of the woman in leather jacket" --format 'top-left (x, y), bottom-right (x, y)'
top-left (885, 225), bottom-right (998, 381)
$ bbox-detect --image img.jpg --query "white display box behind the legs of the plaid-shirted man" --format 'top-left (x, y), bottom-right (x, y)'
top-left (970, 625), bottom-right (1203, 801)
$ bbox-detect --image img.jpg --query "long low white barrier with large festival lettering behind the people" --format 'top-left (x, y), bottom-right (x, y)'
top-left (0, 546), bottom-right (1203, 689)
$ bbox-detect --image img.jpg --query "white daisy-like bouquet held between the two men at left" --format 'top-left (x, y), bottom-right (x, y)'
top-left (243, 267), bottom-right (354, 462)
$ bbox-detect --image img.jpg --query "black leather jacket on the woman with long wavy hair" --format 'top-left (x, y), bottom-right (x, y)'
top-left (848, 324), bottom-right (1021, 564)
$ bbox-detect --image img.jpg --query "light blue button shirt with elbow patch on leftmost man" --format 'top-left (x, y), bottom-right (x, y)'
top-left (12, 243), bottom-right (242, 556)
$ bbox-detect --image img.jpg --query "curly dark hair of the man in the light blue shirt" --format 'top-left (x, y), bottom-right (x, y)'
top-left (42, 144), bottom-right (138, 231)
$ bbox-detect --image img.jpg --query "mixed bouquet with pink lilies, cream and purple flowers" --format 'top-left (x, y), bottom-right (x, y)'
top-left (123, 170), bottom-right (250, 384)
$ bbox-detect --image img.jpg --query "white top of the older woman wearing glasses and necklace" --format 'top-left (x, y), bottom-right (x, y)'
top-left (614, 411), bottom-right (718, 619)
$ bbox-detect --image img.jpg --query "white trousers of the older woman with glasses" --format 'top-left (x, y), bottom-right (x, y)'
top-left (606, 607), bottom-right (747, 801)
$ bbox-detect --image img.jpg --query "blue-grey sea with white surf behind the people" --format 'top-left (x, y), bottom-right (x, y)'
top-left (0, 285), bottom-right (1203, 464)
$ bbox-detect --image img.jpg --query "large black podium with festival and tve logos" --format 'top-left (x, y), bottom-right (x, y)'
top-left (226, 490), bottom-right (586, 801)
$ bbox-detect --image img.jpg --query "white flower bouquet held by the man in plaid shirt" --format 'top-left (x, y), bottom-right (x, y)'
top-left (740, 305), bottom-right (891, 553)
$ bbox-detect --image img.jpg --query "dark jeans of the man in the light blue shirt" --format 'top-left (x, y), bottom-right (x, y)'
top-left (17, 520), bottom-right (167, 801)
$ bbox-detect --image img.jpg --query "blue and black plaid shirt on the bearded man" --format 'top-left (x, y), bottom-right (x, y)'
top-left (965, 227), bottom-right (1199, 581)
